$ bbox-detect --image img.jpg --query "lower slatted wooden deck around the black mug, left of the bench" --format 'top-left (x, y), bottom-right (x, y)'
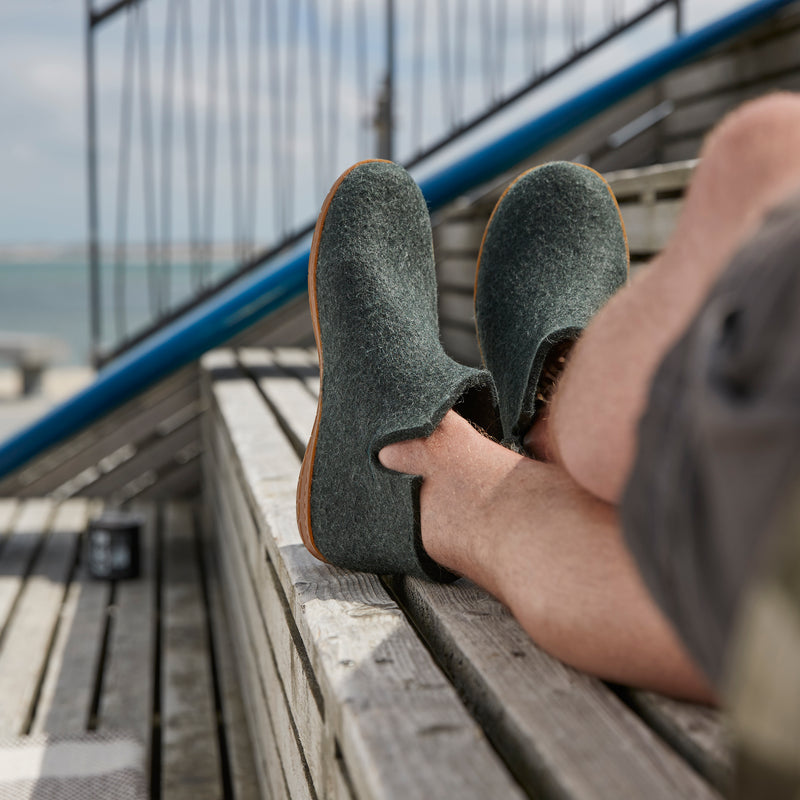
top-left (0, 498), bottom-right (259, 800)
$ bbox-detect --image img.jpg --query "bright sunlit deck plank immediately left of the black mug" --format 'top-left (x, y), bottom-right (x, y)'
top-left (0, 502), bottom-right (86, 735)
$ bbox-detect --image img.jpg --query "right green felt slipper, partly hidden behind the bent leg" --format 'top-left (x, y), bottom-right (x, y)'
top-left (475, 162), bottom-right (628, 443)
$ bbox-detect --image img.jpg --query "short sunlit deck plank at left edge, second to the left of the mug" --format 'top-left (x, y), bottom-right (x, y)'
top-left (0, 499), bottom-right (55, 642)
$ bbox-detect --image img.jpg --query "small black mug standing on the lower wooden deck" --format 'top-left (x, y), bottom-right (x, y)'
top-left (86, 511), bottom-right (142, 581)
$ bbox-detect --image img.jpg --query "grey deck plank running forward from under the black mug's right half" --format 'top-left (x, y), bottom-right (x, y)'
top-left (97, 506), bottom-right (158, 752)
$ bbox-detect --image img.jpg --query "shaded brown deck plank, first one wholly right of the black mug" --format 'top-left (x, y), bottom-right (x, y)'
top-left (161, 503), bottom-right (222, 800)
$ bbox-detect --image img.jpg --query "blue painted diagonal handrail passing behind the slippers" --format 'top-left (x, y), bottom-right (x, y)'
top-left (0, 0), bottom-right (793, 478)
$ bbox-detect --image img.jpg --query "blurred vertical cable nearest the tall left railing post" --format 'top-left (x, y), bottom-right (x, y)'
top-left (114, 6), bottom-right (135, 339)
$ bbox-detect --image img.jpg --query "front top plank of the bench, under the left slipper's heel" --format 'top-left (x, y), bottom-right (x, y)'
top-left (205, 354), bottom-right (519, 797)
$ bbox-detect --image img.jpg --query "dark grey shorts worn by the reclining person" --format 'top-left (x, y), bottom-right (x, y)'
top-left (620, 189), bottom-right (800, 686)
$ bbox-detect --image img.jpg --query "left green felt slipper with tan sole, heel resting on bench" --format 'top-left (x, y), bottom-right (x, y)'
top-left (297, 160), bottom-right (499, 580)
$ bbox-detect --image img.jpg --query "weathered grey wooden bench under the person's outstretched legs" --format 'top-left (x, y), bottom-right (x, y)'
top-left (201, 349), bottom-right (729, 800)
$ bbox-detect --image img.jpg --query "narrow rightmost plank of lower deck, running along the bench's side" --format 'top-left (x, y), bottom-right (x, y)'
top-left (204, 551), bottom-right (260, 800)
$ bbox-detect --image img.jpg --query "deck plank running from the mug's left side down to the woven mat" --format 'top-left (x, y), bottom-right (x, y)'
top-left (31, 501), bottom-right (111, 736)
